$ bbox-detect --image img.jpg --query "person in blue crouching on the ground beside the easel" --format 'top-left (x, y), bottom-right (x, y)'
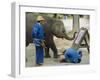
top-left (60, 48), bottom-right (82, 63)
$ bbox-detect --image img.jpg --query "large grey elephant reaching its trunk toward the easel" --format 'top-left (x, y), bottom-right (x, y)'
top-left (26, 12), bottom-right (75, 58)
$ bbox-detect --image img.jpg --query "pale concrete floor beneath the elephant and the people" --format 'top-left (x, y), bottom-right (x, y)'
top-left (26, 37), bottom-right (89, 67)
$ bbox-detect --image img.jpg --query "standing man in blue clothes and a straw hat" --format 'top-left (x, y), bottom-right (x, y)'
top-left (32, 16), bottom-right (46, 66)
